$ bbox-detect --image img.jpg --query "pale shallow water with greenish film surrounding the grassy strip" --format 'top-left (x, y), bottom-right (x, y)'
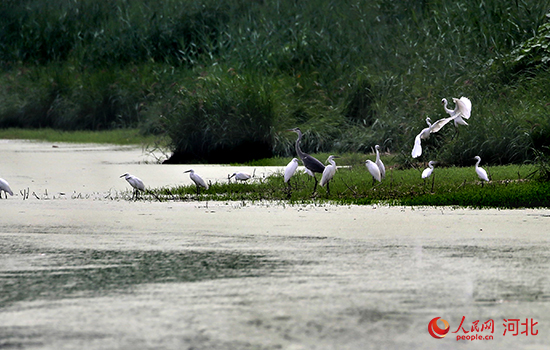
top-left (0, 142), bottom-right (550, 349)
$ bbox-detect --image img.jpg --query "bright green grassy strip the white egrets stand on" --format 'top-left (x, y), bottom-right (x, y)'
top-left (146, 162), bottom-right (550, 208)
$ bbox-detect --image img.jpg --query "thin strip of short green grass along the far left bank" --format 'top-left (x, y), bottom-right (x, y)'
top-left (0, 128), bottom-right (157, 145)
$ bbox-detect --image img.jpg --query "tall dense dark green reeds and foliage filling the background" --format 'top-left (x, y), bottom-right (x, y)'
top-left (0, 0), bottom-right (550, 165)
